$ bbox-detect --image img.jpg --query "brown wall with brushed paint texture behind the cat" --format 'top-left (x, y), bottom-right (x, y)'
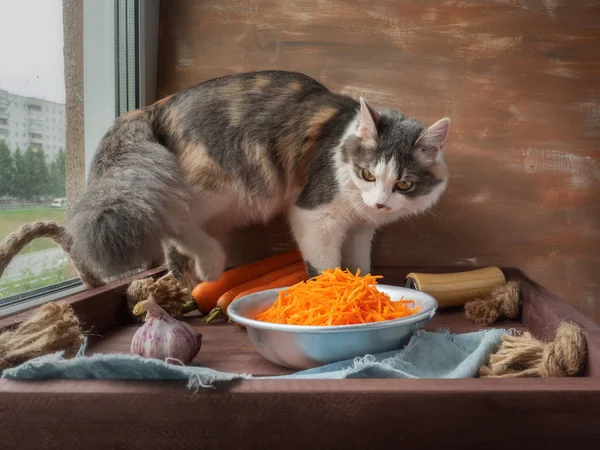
top-left (158, 0), bottom-right (600, 319)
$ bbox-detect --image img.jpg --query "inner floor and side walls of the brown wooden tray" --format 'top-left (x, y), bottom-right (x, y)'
top-left (0, 267), bottom-right (600, 378)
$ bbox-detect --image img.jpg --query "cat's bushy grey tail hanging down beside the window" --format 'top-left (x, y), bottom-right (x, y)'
top-left (67, 123), bottom-right (189, 277)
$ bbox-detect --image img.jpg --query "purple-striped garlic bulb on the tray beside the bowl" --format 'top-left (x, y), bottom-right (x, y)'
top-left (130, 300), bottom-right (202, 364)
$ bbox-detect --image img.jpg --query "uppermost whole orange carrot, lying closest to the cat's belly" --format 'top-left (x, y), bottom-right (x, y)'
top-left (192, 249), bottom-right (302, 314)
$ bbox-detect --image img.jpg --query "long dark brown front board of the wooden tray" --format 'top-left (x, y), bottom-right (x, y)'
top-left (0, 379), bottom-right (600, 450)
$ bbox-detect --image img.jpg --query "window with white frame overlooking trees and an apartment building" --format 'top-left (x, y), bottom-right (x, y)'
top-left (0, 0), bottom-right (158, 316)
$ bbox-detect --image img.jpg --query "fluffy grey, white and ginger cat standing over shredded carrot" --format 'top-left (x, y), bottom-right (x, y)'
top-left (67, 71), bottom-right (450, 281)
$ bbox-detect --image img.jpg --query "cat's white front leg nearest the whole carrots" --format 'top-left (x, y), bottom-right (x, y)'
top-left (288, 206), bottom-right (346, 277)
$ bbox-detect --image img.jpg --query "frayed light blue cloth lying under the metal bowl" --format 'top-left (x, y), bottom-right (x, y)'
top-left (2, 329), bottom-right (507, 389)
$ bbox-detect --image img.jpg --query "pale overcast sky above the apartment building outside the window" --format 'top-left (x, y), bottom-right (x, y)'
top-left (0, 0), bottom-right (65, 103)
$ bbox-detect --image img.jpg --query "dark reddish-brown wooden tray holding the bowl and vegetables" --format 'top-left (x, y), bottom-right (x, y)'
top-left (0, 268), bottom-right (600, 449)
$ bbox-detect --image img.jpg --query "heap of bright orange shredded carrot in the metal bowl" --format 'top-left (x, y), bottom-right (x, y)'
top-left (256, 268), bottom-right (420, 326)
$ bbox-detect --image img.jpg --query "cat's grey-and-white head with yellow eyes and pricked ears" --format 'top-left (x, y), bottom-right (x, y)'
top-left (341, 98), bottom-right (450, 214)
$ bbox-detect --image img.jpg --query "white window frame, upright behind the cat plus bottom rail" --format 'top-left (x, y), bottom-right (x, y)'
top-left (0, 0), bottom-right (160, 317)
